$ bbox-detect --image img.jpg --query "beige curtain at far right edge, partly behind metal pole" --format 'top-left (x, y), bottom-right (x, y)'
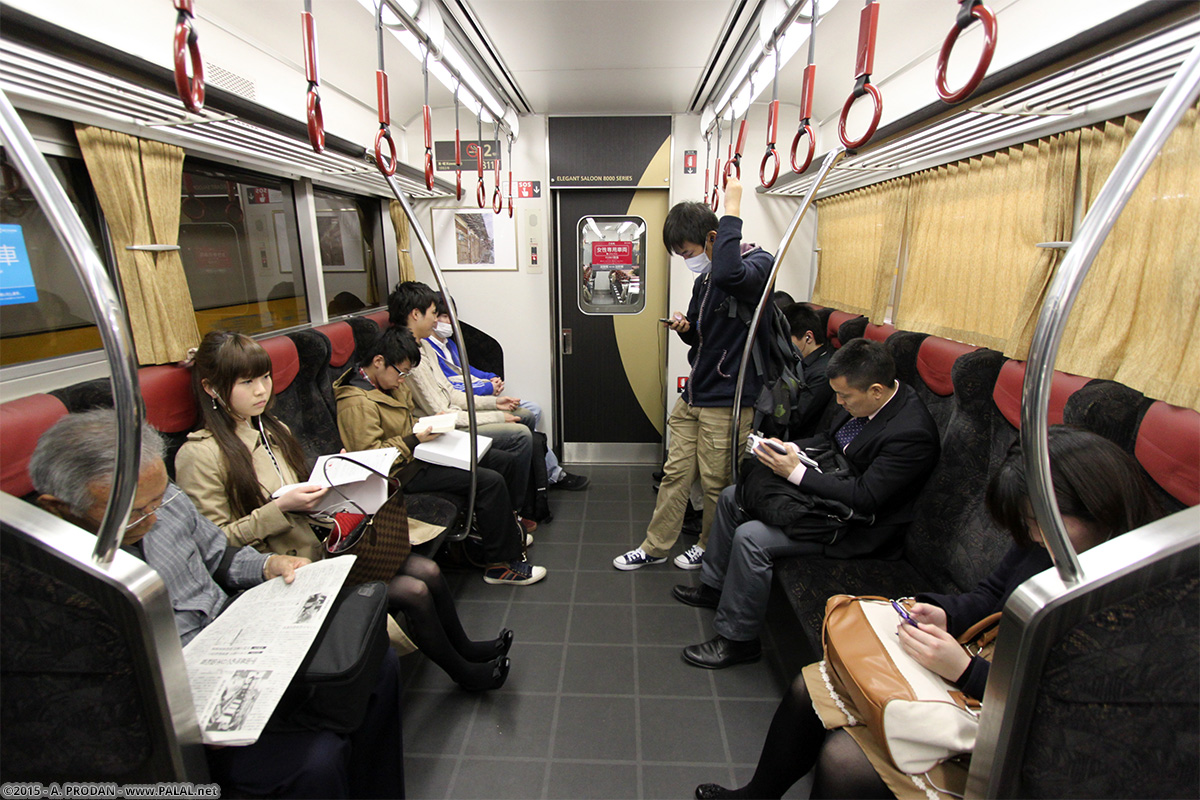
top-left (1055, 108), bottom-right (1200, 410)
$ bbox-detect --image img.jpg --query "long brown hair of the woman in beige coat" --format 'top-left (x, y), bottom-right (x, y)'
top-left (192, 331), bottom-right (308, 517)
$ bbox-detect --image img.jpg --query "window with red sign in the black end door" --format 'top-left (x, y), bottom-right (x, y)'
top-left (576, 217), bottom-right (646, 314)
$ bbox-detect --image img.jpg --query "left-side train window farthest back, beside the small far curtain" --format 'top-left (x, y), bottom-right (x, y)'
top-left (313, 188), bottom-right (386, 317)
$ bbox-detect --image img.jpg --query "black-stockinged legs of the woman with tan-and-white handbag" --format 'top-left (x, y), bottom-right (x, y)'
top-left (710, 675), bottom-right (893, 799)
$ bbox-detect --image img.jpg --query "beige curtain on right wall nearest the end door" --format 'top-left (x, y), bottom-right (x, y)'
top-left (812, 178), bottom-right (910, 323)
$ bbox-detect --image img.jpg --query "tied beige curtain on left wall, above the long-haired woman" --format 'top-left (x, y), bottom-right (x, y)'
top-left (76, 125), bottom-right (200, 365)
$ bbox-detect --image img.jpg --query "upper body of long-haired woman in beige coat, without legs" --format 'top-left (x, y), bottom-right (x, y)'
top-left (175, 331), bottom-right (329, 560)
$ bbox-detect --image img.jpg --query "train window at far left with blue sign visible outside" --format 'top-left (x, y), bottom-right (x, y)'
top-left (0, 149), bottom-right (104, 366)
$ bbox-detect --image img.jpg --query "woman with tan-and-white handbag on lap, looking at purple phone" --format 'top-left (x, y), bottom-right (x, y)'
top-left (696, 426), bottom-right (1160, 800)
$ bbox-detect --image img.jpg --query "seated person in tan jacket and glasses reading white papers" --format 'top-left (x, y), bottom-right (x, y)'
top-left (334, 327), bottom-right (546, 587)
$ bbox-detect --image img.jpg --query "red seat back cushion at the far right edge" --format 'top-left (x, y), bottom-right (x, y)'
top-left (1134, 401), bottom-right (1200, 506)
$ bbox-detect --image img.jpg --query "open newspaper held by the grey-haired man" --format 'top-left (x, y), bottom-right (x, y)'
top-left (184, 555), bottom-right (355, 745)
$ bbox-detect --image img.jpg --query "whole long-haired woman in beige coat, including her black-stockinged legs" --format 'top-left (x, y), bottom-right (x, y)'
top-left (175, 331), bottom-right (512, 691)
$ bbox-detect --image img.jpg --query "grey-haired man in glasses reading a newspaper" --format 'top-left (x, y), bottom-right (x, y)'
top-left (29, 409), bottom-right (404, 798)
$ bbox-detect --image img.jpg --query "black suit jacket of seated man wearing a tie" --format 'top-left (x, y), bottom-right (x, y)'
top-left (797, 381), bottom-right (941, 558)
